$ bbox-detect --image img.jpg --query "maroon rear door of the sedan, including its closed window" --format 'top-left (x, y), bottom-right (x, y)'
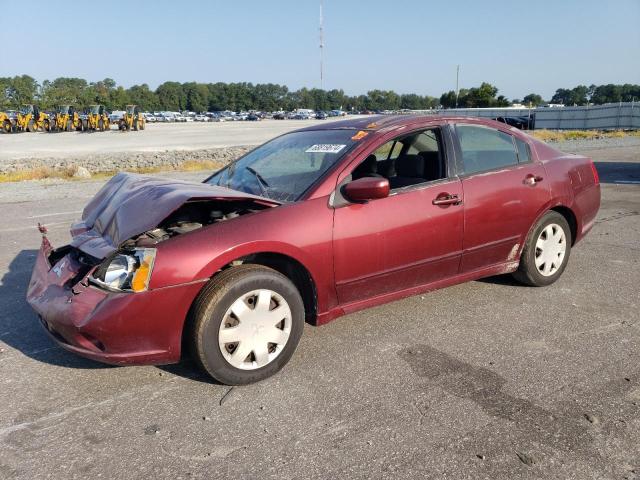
top-left (455, 124), bottom-right (551, 272)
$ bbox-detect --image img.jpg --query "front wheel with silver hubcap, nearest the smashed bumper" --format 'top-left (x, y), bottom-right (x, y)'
top-left (191, 265), bottom-right (305, 385)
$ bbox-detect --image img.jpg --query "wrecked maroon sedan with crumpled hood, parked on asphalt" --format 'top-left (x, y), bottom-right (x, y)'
top-left (28, 116), bottom-right (600, 384)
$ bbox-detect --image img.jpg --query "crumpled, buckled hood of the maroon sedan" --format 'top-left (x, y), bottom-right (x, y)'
top-left (71, 173), bottom-right (279, 259)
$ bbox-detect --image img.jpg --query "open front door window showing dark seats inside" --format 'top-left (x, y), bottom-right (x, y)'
top-left (351, 128), bottom-right (447, 190)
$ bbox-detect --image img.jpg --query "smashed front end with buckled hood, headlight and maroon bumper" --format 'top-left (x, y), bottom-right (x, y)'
top-left (27, 174), bottom-right (277, 364)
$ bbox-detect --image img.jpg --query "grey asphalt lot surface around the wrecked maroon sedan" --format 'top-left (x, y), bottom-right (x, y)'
top-left (0, 142), bottom-right (640, 479)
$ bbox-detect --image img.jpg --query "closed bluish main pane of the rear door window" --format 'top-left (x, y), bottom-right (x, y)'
top-left (456, 125), bottom-right (518, 174)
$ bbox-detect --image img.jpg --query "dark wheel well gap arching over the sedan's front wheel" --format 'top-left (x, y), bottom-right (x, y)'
top-left (238, 252), bottom-right (318, 324)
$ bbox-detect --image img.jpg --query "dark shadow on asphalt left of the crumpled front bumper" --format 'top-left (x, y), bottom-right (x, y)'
top-left (0, 250), bottom-right (113, 369)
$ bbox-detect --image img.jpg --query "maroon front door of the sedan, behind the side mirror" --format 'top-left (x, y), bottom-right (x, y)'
top-left (333, 129), bottom-right (464, 305)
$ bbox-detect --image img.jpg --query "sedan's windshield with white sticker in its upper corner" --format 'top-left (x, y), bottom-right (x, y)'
top-left (207, 130), bottom-right (356, 202)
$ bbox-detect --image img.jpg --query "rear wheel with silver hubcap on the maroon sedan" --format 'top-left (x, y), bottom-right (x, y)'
top-left (513, 211), bottom-right (573, 287)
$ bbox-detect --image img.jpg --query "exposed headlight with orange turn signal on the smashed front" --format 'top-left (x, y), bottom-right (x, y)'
top-left (91, 248), bottom-right (156, 292)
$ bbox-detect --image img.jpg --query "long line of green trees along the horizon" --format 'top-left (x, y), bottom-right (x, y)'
top-left (0, 75), bottom-right (640, 112)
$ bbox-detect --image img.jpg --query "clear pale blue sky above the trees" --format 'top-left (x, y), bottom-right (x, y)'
top-left (0, 0), bottom-right (640, 98)
